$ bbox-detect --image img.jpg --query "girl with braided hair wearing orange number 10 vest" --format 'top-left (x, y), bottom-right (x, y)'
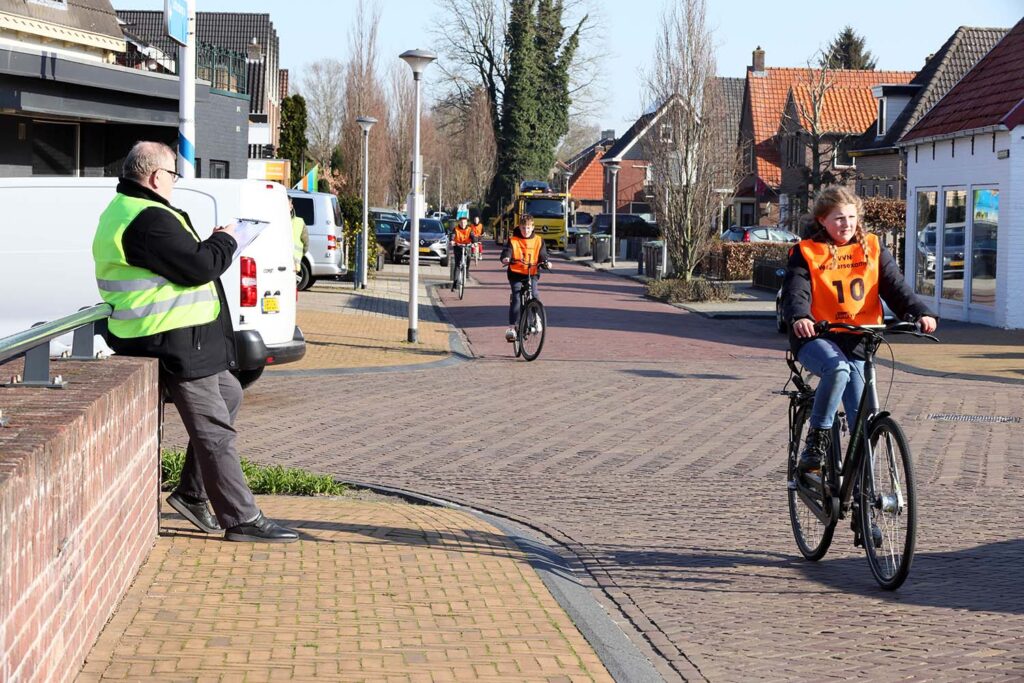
top-left (782, 185), bottom-right (937, 472)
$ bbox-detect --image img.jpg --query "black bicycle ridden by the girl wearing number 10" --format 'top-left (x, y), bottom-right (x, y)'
top-left (777, 322), bottom-right (938, 591)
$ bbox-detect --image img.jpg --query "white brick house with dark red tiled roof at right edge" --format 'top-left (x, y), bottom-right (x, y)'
top-left (896, 19), bottom-right (1024, 329)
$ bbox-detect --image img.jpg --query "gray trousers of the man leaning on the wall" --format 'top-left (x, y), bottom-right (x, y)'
top-left (160, 370), bottom-right (259, 528)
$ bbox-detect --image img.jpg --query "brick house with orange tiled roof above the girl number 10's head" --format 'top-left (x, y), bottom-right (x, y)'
top-left (776, 70), bottom-right (914, 231)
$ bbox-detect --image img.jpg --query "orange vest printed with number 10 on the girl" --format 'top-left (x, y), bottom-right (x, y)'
top-left (799, 234), bottom-right (882, 325)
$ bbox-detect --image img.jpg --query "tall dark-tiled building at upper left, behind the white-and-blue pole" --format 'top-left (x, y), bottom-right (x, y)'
top-left (118, 9), bottom-right (282, 165)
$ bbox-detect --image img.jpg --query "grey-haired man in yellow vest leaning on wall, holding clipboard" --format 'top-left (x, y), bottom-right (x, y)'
top-left (92, 142), bottom-right (298, 543)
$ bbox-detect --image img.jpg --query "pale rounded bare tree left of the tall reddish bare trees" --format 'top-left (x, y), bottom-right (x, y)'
top-left (300, 59), bottom-right (345, 169)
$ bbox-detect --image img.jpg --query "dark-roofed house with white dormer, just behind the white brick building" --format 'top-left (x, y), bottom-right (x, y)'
top-left (850, 27), bottom-right (1008, 199)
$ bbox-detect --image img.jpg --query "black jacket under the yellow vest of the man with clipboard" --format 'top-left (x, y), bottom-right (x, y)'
top-left (106, 178), bottom-right (238, 379)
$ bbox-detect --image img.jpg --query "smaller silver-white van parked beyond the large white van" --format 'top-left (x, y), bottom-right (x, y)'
top-left (288, 189), bottom-right (348, 291)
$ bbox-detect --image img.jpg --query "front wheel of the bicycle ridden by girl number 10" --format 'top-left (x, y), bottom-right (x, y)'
top-left (859, 417), bottom-right (918, 591)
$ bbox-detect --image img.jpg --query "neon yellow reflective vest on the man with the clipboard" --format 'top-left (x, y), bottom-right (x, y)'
top-left (92, 194), bottom-right (220, 339)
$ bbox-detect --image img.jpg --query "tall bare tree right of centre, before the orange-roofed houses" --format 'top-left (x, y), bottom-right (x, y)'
top-left (643, 0), bottom-right (737, 281)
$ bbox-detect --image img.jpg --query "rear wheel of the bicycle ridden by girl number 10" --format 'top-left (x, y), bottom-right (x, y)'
top-left (786, 407), bottom-right (837, 562)
